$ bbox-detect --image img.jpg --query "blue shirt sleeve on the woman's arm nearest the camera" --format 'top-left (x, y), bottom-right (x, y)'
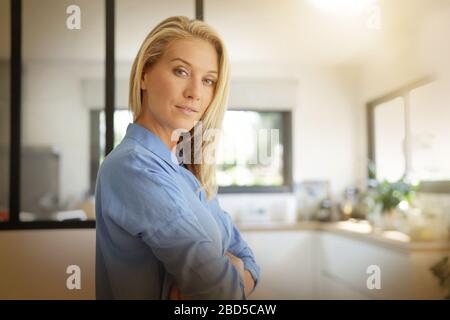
top-left (102, 155), bottom-right (244, 299)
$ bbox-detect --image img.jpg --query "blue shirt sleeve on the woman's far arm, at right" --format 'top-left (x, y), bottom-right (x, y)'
top-left (207, 197), bottom-right (260, 292)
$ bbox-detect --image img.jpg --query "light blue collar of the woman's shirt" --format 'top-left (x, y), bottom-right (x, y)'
top-left (125, 123), bottom-right (180, 171)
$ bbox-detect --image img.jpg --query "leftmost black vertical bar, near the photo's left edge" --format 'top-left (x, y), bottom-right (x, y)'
top-left (9, 0), bottom-right (22, 223)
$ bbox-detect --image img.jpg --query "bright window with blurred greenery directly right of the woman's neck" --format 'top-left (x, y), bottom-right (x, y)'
top-left (217, 110), bottom-right (292, 192)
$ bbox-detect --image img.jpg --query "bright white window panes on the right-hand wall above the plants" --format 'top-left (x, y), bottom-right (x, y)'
top-left (368, 79), bottom-right (450, 193)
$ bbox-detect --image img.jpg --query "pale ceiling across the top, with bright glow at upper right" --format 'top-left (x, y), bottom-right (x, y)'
top-left (0, 0), bottom-right (450, 65)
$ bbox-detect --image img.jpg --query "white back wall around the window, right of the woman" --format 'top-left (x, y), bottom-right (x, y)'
top-left (220, 63), bottom-right (366, 216)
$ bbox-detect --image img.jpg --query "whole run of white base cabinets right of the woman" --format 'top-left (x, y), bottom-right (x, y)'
top-left (242, 224), bottom-right (450, 299)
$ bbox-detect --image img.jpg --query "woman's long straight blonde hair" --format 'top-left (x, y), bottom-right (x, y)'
top-left (129, 16), bottom-right (230, 199)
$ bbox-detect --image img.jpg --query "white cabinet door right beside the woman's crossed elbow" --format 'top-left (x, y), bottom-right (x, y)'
top-left (242, 231), bottom-right (315, 299)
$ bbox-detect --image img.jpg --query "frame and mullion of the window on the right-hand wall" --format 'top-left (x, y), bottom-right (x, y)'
top-left (366, 76), bottom-right (450, 194)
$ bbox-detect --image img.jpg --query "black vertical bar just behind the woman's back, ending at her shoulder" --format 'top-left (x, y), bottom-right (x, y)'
top-left (105, 0), bottom-right (115, 156)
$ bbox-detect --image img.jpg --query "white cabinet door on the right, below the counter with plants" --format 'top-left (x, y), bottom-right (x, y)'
top-left (316, 232), bottom-right (412, 299)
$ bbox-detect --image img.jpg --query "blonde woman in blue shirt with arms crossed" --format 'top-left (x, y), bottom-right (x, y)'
top-left (96, 17), bottom-right (259, 299)
